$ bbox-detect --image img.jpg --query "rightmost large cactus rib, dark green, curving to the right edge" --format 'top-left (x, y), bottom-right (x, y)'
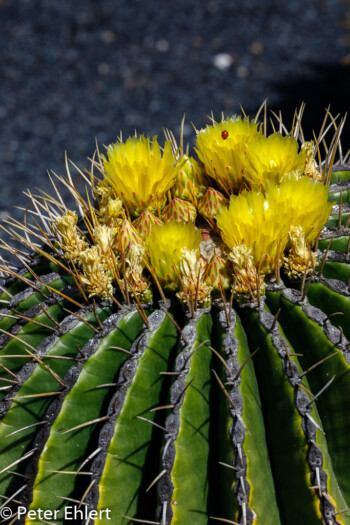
top-left (268, 290), bottom-right (350, 520)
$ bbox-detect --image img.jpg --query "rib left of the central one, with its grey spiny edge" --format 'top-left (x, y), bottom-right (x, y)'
top-left (88, 310), bottom-right (178, 525)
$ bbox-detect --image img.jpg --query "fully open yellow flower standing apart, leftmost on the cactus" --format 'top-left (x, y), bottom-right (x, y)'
top-left (103, 135), bottom-right (178, 216)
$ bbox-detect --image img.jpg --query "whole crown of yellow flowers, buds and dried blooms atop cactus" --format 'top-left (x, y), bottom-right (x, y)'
top-left (55, 117), bottom-right (332, 304)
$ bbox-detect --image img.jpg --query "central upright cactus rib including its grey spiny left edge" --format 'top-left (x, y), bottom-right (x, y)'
top-left (159, 310), bottom-right (212, 524)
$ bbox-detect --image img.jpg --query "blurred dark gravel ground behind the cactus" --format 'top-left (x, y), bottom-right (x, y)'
top-left (0, 0), bottom-right (350, 229)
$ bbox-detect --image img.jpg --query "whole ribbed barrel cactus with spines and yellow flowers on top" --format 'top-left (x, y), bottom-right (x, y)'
top-left (0, 107), bottom-right (350, 525)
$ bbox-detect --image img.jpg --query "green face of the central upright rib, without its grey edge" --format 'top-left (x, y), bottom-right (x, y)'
top-left (170, 313), bottom-right (212, 525)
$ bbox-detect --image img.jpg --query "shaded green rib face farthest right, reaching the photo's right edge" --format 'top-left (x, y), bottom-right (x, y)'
top-left (267, 293), bottom-right (350, 523)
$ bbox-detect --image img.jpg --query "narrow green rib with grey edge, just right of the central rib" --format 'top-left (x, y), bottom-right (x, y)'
top-left (209, 311), bottom-right (280, 524)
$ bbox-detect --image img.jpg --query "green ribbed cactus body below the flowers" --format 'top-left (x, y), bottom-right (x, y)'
top-left (0, 262), bottom-right (350, 524)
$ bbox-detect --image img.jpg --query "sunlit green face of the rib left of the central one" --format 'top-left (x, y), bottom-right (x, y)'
top-left (95, 311), bottom-right (178, 525)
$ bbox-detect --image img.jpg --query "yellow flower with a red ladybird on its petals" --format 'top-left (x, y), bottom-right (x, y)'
top-left (196, 116), bottom-right (261, 194)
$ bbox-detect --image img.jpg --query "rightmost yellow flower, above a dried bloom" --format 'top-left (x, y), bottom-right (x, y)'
top-left (266, 174), bottom-right (332, 242)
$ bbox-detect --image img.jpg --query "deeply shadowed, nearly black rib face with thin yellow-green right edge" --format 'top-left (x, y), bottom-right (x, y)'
top-left (242, 307), bottom-right (321, 525)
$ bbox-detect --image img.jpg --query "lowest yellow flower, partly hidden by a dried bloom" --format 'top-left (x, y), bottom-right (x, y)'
top-left (147, 222), bottom-right (202, 290)
